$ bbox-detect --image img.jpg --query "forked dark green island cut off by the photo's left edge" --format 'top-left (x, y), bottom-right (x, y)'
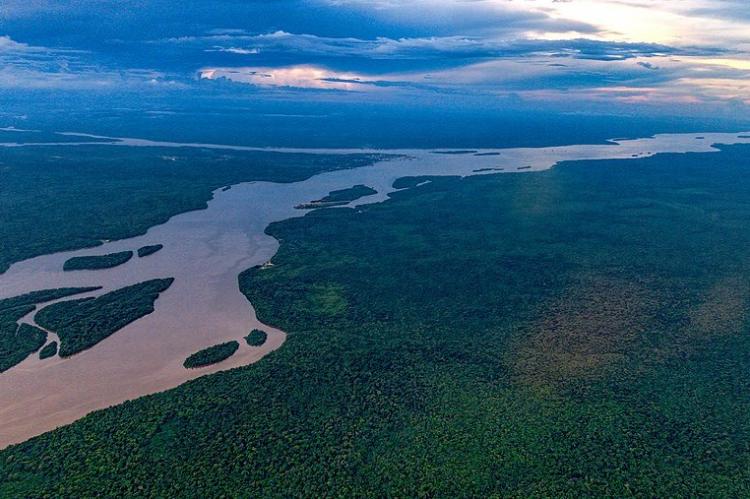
top-left (0, 288), bottom-right (98, 372)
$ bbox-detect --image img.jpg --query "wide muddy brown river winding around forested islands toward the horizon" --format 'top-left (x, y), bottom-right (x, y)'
top-left (0, 133), bottom-right (750, 448)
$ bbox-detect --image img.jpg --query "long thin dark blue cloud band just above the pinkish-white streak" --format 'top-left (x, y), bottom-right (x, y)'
top-left (139, 31), bottom-right (724, 78)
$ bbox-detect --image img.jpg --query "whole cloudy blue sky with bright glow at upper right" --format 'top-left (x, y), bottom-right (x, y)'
top-left (0, 0), bottom-right (750, 135)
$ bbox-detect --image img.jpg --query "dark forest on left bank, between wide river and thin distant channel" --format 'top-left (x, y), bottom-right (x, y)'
top-left (0, 146), bottom-right (382, 272)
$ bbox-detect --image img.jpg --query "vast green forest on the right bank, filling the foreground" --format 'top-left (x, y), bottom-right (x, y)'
top-left (0, 146), bottom-right (750, 497)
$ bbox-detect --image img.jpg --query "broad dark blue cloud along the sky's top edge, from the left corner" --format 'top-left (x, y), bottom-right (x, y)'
top-left (3, 0), bottom-right (597, 47)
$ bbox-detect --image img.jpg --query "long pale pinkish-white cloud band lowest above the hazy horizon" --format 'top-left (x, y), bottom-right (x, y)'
top-left (200, 49), bottom-right (750, 107)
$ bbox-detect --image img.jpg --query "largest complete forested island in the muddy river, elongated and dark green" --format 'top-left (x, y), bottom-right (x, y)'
top-left (35, 278), bottom-right (174, 357)
